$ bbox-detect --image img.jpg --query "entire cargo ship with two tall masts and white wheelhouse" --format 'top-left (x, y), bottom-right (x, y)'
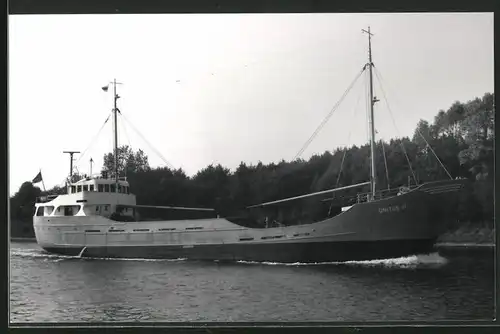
top-left (33, 28), bottom-right (466, 263)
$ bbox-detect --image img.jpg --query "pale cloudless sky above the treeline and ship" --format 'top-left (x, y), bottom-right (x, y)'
top-left (8, 13), bottom-right (494, 195)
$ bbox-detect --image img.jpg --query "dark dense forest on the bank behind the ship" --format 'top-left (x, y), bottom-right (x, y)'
top-left (10, 93), bottom-right (495, 237)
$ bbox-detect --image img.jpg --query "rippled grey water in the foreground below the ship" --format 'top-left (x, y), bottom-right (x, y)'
top-left (10, 243), bottom-right (494, 322)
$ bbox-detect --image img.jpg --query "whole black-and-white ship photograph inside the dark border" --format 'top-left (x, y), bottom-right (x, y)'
top-left (7, 12), bottom-right (496, 326)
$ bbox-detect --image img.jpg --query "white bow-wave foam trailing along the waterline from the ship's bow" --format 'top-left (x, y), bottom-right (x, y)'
top-left (237, 252), bottom-right (448, 269)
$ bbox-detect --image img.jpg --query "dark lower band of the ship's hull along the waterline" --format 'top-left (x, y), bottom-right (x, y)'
top-left (45, 239), bottom-right (435, 263)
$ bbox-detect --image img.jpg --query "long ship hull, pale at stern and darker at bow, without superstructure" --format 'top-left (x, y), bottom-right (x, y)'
top-left (34, 184), bottom-right (460, 263)
